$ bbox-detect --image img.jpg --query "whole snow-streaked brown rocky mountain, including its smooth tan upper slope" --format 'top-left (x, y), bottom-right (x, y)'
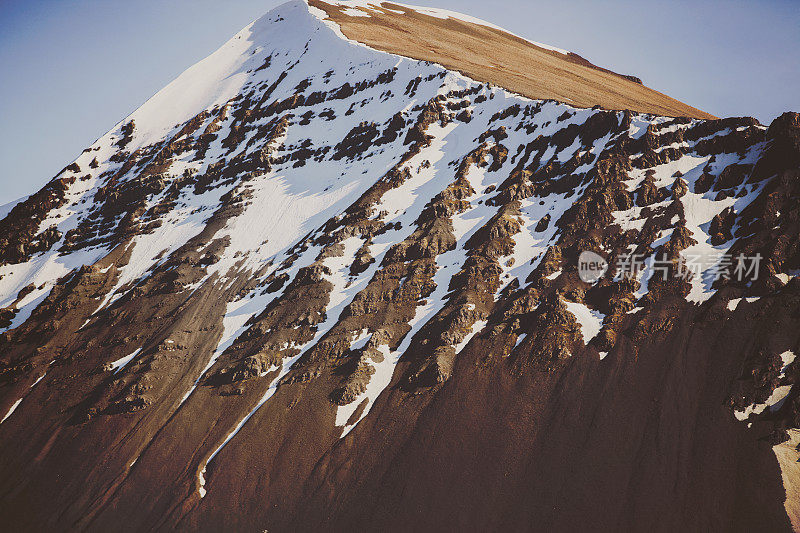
top-left (0, 0), bottom-right (800, 531)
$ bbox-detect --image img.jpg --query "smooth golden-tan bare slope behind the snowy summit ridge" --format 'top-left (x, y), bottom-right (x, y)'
top-left (309, 0), bottom-right (716, 119)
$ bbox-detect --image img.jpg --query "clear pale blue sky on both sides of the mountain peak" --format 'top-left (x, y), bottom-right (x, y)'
top-left (0, 0), bottom-right (800, 206)
